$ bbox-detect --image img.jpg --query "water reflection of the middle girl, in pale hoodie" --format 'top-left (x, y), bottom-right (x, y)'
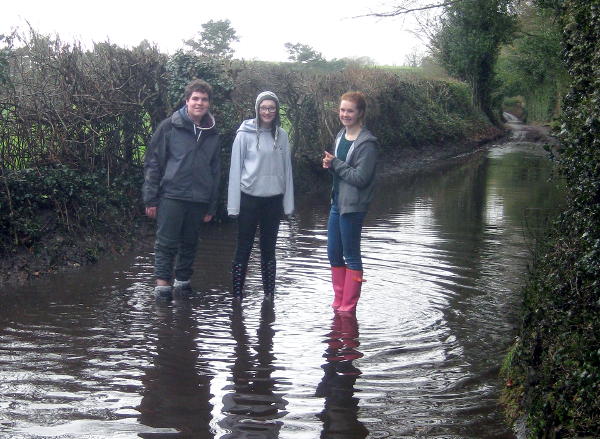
top-left (219, 297), bottom-right (287, 439)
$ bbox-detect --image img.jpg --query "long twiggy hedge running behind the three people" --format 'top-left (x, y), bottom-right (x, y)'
top-left (0, 30), bottom-right (486, 262)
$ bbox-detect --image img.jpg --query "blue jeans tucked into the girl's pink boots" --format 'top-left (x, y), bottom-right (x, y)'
top-left (327, 203), bottom-right (366, 271)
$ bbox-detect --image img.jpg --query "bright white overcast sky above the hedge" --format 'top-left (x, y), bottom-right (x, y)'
top-left (0, 0), bottom-right (425, 65)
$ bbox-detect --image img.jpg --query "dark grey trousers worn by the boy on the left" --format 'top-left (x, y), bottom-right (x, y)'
top-left (154, 198), bottom-right (208, 281)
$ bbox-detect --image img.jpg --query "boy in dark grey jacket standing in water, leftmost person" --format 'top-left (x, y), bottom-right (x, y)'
top-left (142, 79), bottom-right (221, 300)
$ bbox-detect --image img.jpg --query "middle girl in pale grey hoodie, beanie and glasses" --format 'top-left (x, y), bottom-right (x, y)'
top-left (227, 91), bottom-right (294, 299)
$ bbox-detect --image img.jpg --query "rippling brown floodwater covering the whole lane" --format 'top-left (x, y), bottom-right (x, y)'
top-left (0, 125), bottom-right (562, 439)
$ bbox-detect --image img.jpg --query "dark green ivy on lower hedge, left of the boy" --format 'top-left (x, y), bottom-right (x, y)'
top-left (0, 165), bottom-right (142, 249)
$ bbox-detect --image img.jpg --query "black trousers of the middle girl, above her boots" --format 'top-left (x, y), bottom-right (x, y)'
top-left (233, 192), bottom-right (283, 265)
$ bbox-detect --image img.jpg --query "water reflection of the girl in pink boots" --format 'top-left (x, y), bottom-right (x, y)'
top-left (315, 313), bottom-right (369, 439)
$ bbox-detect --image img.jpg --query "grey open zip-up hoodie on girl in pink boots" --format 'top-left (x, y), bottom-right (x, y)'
top-left (329, 127), bottom-right (379, 215)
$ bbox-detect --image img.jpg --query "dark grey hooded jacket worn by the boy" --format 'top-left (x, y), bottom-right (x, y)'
top-left (142, 107), bottom-right (221, 215)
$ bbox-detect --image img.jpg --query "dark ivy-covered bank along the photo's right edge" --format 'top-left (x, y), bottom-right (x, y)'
top-left (504, 0), bottom-right (600, 438)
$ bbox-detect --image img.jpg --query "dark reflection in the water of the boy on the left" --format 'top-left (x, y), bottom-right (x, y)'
top-left (139, 301), bottom-right (214, 439)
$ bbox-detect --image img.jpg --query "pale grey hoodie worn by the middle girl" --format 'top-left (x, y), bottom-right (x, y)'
top-left (227, 119), bottom-right (294, 216)
